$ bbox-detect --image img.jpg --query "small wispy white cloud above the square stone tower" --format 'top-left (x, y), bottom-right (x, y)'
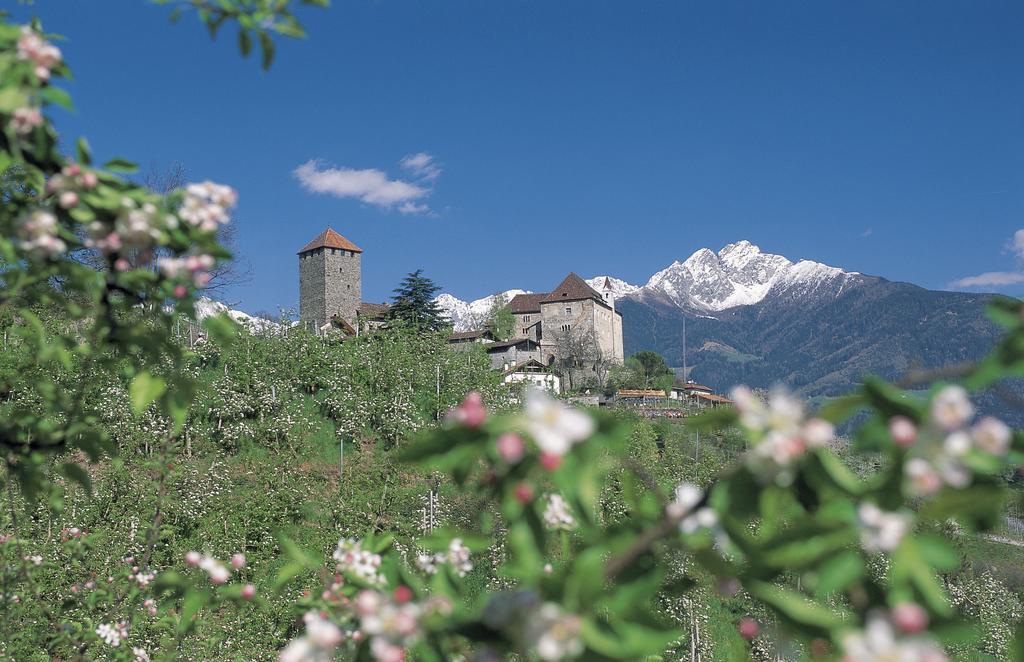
top-left (293, 153), bottom-right (441, 214)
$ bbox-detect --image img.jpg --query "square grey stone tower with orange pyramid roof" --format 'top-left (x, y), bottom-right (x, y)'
top-left (299, 227), bottom-right (362, 329)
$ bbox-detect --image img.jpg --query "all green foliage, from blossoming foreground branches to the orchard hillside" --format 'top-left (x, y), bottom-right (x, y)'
top-left (0, 5), bottom-right (1024, 660)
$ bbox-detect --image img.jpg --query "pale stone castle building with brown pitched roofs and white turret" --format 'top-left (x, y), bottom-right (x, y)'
top-left (509, 274), bottom-right (625, 364)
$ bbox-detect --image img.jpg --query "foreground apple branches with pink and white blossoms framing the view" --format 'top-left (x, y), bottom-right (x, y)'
top-left (0, 5), bottom-right (1024, 662)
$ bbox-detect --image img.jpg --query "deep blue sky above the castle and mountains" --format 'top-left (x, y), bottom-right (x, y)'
top-left (13, 0), bottom-right (1024, 311)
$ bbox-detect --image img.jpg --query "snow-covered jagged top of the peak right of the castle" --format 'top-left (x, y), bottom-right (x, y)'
top-left (637, 240), bottom-right (860, 312)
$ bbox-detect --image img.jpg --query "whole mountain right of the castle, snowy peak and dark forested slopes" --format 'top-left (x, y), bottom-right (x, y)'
top-left (432, 241), bottom-right (999, 407)
